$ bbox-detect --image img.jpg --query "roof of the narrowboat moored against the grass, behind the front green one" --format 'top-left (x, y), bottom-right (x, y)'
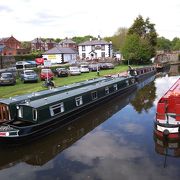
top-left (0, 77), bottom-right (106, 104)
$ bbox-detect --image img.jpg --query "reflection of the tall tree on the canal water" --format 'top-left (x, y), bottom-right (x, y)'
top-left (131, 82), bottom-right (156, 113)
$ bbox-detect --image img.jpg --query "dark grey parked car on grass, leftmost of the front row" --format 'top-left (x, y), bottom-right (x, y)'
top-left (0, 72), bottom-right (16, 85)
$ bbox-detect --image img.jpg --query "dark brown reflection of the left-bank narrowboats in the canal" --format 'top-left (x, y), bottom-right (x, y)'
top-left (0, 77), bottom-right (154, 169)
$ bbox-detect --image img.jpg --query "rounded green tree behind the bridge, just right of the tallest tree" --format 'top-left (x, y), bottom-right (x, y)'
top-left (157, 37), bottom-right (172, 51)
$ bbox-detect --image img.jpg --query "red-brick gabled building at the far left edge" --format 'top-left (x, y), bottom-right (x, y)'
top-left (0, 36), bottom-right (21, 56)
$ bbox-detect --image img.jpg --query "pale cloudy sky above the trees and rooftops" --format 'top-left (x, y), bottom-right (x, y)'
top-left (0, 0), bottom-right (180, 41)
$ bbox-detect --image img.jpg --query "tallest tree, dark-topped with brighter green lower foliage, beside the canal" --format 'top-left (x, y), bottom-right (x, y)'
top-left (122, 15), bottom-right (157, 64)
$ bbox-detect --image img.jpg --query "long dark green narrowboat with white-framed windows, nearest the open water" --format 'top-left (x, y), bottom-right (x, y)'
top-left (0, 76), bottom-right (137, 143)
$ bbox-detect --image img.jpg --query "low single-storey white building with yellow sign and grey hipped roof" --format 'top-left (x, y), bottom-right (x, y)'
top-left (43, 45), bottom-right (78, 64)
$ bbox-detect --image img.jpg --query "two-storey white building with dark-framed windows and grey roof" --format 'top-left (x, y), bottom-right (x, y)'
top-left (78, 38), bottom-right (112, 59)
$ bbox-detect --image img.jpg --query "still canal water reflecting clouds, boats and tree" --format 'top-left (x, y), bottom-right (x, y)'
top-left (0, 66), bottom-right (180, 180)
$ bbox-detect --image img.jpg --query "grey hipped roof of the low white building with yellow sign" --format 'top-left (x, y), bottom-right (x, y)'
top-left (43, 46), bottom-right (78, 54)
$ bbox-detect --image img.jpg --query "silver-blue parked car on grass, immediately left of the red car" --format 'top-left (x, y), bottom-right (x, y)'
top-left (20, 70), bottom-right (38, 83)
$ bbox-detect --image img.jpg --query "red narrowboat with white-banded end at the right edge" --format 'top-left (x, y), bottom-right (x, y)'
top-left (155, 78), bottom-right (180, 139)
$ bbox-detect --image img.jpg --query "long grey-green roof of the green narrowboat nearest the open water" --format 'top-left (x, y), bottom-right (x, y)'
top-left (21, 77), bottom-right (130, 108)
